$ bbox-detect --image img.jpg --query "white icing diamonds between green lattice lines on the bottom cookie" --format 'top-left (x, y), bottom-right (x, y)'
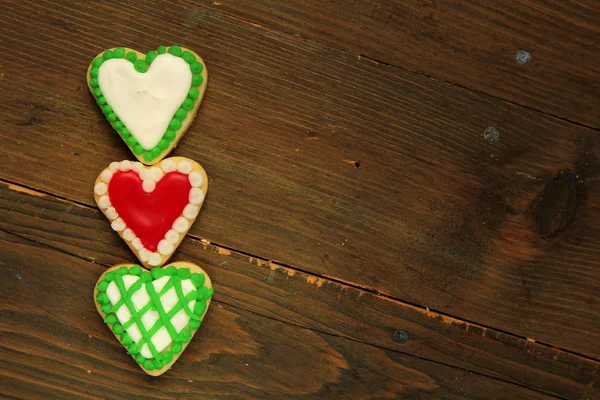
top-left (106, 275), bottom-right (196, 358)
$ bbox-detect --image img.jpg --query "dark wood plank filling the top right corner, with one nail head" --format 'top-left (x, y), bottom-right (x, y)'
top-left (190, 0), bottom-right (600, 128)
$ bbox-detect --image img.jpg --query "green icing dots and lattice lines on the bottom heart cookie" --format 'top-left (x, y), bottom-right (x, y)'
top-left (95, 265), bottom-right (214, 371)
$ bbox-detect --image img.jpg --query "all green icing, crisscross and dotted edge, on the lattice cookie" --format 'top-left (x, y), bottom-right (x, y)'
top-left (96, 265), bottom-right (212, 370)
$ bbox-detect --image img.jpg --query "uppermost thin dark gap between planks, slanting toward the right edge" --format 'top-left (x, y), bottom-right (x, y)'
top-left (180, 0), bottom-right (600, 132)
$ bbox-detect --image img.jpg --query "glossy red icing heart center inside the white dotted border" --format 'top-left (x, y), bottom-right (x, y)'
top-left (108, 171), bottom-right (192, 251)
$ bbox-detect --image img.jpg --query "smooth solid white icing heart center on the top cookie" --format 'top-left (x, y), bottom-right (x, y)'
top-left (98, 53), bottom-right (192, 150)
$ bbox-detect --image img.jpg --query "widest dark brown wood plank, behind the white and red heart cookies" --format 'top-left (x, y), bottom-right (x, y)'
top-left (0, 1), bottom-right (600, 357)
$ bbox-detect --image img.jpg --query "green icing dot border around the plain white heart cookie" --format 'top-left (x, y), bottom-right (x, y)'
top-left (88, 45), bottom-right (204, 163)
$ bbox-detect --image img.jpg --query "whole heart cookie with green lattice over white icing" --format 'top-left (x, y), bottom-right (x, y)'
top-left (94, 262), bottom-right (213, 376)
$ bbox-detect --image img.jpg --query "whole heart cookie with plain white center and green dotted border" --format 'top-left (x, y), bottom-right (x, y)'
top-left (87, 46), bottom-right (208, 165)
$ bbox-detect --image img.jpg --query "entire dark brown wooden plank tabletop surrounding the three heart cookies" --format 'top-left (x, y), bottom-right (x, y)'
top-left (0, 0), bottom-right (600, 400)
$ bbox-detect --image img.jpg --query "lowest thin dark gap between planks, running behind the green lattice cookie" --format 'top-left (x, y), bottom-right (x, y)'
top-left (0, 228), bottom-right (568, 400)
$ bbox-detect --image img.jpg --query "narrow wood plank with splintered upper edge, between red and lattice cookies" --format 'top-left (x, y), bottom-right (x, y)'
top-left (0, 185), bottom-right (600, 399)
